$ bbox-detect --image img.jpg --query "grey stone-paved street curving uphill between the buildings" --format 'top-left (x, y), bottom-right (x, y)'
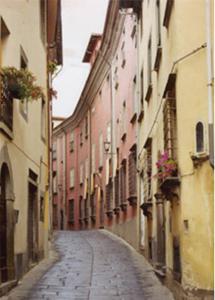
top-left (2, 230), bottom-right (173, 300)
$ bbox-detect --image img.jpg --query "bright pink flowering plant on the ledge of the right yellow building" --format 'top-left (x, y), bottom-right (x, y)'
top-left (155, 151), bottom-right (177, 180)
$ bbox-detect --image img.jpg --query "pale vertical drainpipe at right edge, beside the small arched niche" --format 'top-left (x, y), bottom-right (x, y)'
top-left (205, 0), bottom-right (214, 167)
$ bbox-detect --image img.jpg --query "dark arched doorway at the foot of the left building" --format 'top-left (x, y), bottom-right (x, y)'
top-left (0, 163), bottom-right (14, 283)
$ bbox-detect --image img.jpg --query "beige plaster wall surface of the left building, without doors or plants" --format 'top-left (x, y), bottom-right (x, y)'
top-left (0, 0), bottom-right (49, 262)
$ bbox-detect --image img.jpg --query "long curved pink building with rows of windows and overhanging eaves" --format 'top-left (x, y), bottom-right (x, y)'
top-left (53, 1), bottom-right (139, 248)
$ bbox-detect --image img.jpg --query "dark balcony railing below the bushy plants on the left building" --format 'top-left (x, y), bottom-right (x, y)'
top-left (0, 85), bottom-right (13, 138)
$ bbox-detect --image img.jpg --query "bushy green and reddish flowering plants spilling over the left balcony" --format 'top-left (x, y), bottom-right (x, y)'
top-left (0, 67), bottom-right (44, 100)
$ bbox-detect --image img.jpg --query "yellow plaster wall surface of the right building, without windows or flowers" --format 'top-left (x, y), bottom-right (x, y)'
top-left (138, 0), bottom-right (213, 290)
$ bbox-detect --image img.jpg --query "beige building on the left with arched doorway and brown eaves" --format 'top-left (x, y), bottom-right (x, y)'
top-left (0, 0), bottom-right (62, 295)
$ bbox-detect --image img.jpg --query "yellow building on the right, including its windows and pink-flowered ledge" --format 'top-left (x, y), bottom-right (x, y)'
top-left (137, 0), bottom-right (213, 299)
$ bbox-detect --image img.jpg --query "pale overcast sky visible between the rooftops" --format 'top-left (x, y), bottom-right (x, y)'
top-left (53, 0), bottom-right (108, 117)
